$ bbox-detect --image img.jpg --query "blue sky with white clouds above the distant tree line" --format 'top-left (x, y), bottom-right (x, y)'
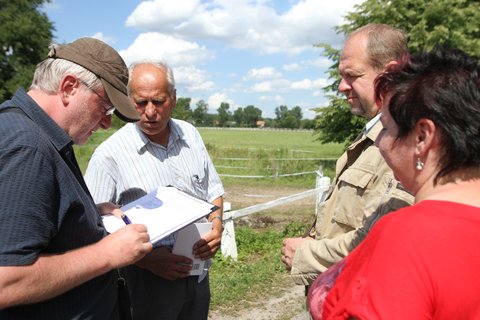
top-left (42, 0), bottom-right (362, 119)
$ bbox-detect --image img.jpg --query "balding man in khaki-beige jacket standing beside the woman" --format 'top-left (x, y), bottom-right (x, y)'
top-left (282, 24), bottom-right (413, 286)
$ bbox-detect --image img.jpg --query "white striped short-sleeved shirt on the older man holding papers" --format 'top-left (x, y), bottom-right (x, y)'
top-left (85, 119), bottom-right (224, 246)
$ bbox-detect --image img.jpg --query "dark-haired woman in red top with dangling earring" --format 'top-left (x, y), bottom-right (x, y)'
top-left (309, 48), bottom-right (480, 320)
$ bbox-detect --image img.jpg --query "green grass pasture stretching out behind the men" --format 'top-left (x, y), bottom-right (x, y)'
top-left (75, 128), bottom-right (343, 187)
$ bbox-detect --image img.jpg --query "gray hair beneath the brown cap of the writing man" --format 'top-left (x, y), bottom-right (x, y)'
top-left (30, 44), bottom-right (102, 94)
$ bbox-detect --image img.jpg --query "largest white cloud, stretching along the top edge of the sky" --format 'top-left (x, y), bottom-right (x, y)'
top-left (126, 0), bottom-right (362, 54)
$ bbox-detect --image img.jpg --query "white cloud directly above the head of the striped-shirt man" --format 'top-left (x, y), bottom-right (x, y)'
top-left (120, 32), bottom-right (213, 67)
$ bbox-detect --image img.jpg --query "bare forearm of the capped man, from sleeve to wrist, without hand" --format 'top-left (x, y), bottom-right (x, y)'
top-left (0, 244), bottom-right (112, 309)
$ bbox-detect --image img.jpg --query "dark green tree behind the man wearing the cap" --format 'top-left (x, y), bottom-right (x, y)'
top-left (0, 0), bottom-right (55, 101)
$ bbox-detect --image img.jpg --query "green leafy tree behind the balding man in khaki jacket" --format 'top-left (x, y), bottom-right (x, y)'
top-left (315, 0), bottom-right (480, 144)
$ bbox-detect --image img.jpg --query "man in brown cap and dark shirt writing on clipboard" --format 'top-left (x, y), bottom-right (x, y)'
top-left (0, 38), bottom-right (152, 320)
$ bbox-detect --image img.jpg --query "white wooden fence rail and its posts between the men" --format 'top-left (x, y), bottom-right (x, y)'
top-left (221, 170), bottom-right (330, 260)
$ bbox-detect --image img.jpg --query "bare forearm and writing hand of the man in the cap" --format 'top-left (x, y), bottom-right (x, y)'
top-left (0, 224), bottom-right (152, 309)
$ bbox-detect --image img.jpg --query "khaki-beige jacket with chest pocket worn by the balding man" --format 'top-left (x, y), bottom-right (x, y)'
top-left (291, 121), bottom-right (413, 285)
